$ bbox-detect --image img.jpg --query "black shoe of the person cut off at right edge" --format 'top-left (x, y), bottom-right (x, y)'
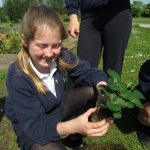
top-left (137, 122), bottom-right (150, 147)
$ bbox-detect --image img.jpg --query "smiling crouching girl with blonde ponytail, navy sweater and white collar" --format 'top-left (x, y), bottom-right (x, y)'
top-left (5, 3), bottom-right (110, 150)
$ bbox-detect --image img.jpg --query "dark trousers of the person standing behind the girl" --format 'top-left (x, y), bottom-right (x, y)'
top-left (77, 9), bottom-right (132, 75)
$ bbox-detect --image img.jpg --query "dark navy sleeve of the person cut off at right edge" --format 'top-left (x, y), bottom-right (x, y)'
top-left (136, 60), bottom-right (150, 102)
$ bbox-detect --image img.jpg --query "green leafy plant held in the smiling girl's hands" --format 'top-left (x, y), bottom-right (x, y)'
top-left (100, 70), bottom-right (144, 118)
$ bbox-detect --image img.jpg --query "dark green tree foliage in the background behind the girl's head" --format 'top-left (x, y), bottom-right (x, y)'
top-left (3, 0), bottom-right (66, 22)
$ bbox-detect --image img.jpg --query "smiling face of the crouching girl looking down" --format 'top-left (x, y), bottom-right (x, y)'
top-left (22, 25), bottom-right (62, 73)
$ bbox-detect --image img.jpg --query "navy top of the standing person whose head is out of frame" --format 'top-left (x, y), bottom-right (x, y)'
top-left (65, 0), bottom-right (131, 19)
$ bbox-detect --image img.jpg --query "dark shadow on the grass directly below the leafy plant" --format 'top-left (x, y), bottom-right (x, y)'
top-left (114, 108), bottom-right (136, 134)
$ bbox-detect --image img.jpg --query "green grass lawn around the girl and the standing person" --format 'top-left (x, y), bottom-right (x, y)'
top-left (0, 18), bottom-right (150, 150)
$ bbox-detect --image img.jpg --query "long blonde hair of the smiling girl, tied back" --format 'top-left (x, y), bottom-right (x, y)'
top-left (15, 3), bottom-right (79, 94)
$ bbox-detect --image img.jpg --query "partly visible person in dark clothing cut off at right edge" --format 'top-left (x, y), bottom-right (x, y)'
top-left (135, 60), bottom-right (150, 147)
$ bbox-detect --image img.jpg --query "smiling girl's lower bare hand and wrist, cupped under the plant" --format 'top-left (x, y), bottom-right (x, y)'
top-left (56, 107), bottom-right (113, 136)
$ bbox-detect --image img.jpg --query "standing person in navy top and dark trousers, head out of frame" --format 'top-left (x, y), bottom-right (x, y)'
top-left (65, 0), bottom-right (132, 75)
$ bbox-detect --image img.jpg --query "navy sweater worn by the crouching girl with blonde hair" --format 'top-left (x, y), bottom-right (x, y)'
top-left (5, 50), bottom-right (107, 145)
